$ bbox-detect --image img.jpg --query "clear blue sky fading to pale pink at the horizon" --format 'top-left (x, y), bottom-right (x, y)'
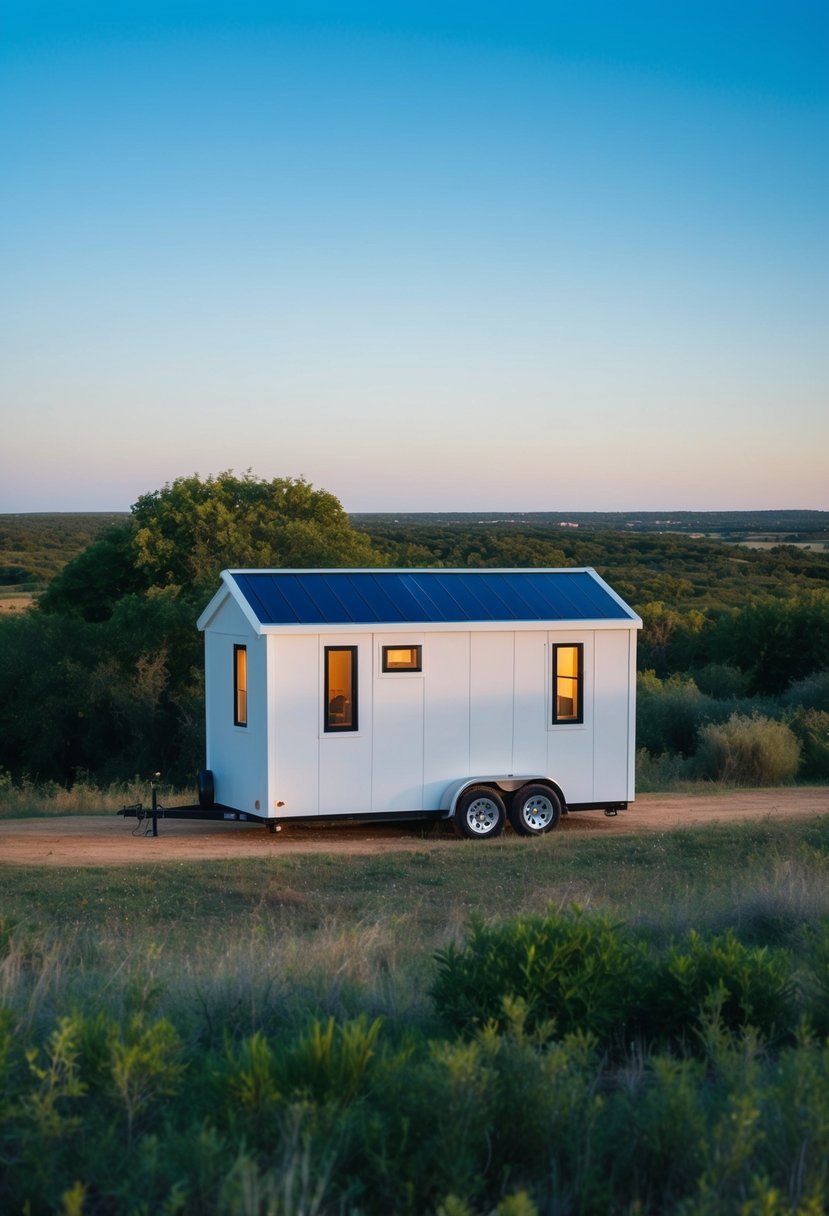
top-left (0, 0), bottom-right (829, 511)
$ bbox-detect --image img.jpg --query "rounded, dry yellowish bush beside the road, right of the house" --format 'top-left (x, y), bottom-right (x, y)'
top-left (697, 714), bottom-right (800, 786)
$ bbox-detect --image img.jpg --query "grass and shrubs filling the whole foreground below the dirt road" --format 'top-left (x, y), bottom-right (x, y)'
top-left (0, 817), bottom-right (829, 1216)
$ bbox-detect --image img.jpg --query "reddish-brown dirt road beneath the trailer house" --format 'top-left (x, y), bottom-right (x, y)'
top-left (0, 786), bottom-right (829, 866)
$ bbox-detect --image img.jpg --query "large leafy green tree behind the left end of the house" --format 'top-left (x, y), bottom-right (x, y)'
top-left (0, 473), bottom-right (383, 782)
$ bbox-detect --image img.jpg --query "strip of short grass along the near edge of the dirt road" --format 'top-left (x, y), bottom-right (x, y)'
top-left (0, 817), bottom-right (829, 957)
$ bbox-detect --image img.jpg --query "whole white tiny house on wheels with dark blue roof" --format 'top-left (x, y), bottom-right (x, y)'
top-left (192, 569), bottom-right (642, 838)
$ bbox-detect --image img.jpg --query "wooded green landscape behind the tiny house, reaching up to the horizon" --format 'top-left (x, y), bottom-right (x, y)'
top-left (0, 473), bottom-right (829, 789)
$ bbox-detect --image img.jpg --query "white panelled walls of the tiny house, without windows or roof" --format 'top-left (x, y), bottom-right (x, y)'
top-left (205, 617), bottom-right (635, 817)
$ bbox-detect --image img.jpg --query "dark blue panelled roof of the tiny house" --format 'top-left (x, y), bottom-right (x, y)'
top-left (222, 570), bottom-right (637, 625)
